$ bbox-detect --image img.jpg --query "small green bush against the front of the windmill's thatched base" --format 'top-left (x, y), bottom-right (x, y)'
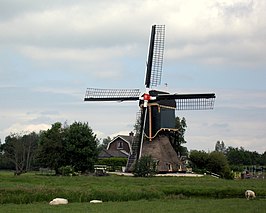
top-left (133, 155), bottom-right (157, 177)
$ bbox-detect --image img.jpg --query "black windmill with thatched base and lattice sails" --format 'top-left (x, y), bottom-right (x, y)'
top-left (84, 25), bottom-right (215, 172)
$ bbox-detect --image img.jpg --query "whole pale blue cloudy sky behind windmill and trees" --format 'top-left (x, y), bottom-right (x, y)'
top-left (0, 0), bottom-right (266, 153)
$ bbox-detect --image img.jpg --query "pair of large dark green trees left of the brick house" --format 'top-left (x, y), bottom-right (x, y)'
top-left (38, 122), bottom-right (98, 174)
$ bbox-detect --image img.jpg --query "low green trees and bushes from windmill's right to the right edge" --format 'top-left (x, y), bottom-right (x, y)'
top-left (189, 141), bottom-right (266, 179)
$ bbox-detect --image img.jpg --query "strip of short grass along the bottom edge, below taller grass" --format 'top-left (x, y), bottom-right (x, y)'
top-left (1, 198), bottom-right (266, 213)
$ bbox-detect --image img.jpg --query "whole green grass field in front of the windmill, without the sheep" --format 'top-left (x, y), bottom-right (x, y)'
top-left (0, 171), bottom-right (266, 213)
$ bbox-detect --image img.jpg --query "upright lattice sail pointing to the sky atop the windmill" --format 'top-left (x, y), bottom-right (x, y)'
top-left (145, 25), bottom-right (165, 88)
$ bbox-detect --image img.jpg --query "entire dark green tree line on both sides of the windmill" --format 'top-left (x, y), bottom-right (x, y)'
top-left (0, 117), bottom-right (266, 178)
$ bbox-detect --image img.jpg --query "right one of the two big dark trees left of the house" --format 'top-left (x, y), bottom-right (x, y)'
top-left (64, 122), bottom-right (98, 172)
